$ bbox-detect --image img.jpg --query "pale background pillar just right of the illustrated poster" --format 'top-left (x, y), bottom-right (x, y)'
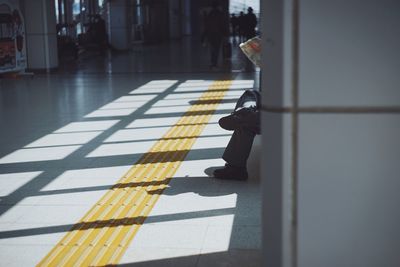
top-left (23, 0), bottom-right (58, 70)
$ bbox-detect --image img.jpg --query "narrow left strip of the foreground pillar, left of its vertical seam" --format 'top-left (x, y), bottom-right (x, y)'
top-left (260, 0), bottom-right (295, 267)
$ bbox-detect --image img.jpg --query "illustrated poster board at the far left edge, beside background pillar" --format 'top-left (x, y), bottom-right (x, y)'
top-left (0, 0), bottom-right (26, 73)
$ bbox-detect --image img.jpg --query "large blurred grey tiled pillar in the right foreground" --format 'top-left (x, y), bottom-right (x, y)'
top-left (261, 0), bottom-right (400, 267)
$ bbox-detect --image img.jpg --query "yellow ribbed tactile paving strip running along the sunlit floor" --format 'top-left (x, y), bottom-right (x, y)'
top-left (37, 80), bottom-right (232, 266)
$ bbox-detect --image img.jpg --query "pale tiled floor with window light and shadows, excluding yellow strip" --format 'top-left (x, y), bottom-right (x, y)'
top-left (0, 40), bottom-right (261, 267)
